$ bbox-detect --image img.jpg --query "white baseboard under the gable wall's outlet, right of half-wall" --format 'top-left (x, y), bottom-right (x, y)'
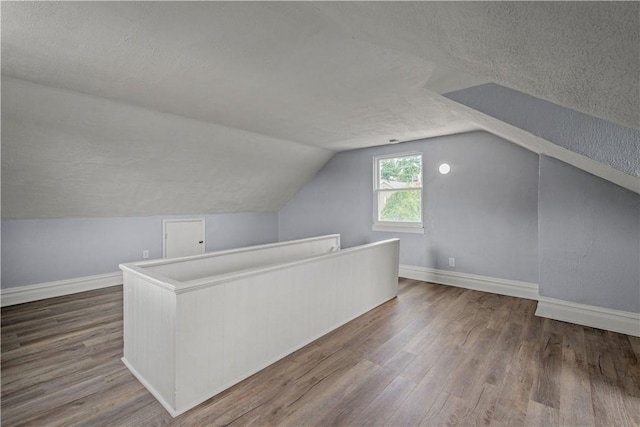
top-left (399, 264), bottom-right (538, 300)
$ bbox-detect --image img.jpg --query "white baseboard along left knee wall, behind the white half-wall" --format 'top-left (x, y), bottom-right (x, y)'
top-left (0, 271), bottom-right (122, 307)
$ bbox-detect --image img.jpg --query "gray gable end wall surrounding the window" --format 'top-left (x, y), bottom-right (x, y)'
top-left (279, 132), bottom-right (538, 283)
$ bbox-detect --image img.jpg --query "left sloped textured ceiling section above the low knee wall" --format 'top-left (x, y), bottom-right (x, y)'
top-left (2, 77), bottom-right (333, 219)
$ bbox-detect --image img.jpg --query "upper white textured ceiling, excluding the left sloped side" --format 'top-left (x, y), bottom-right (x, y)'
top-left (2, 2), bottom-right (640, 149)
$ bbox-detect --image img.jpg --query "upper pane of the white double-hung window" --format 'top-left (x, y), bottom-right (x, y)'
top-left (378, 155), bottom-right (422, 190)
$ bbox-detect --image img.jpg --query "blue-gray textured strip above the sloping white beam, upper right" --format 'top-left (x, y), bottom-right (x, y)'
top-left (445, 83), bottom-right (640, 176)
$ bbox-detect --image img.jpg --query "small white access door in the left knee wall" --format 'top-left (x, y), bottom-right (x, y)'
top-left (163, 219), bottom-right (205, 258)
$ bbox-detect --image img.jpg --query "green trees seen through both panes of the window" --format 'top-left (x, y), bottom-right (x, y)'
top-left (377, 154), bottom-right (422, 222)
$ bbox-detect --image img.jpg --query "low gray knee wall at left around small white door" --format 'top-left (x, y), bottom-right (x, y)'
top-left (2, 212), bottom-right (278, 288)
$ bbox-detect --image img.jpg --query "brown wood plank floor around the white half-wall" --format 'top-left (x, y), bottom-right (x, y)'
top-left (1, 279), bottom-right (640, 426)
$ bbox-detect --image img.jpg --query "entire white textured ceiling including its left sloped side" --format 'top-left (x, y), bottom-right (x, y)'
top-left (1, 2), bottom-right (640, 218)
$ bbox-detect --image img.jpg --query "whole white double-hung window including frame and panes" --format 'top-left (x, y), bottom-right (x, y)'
top-left (373, 153), bottom-right (424, 233)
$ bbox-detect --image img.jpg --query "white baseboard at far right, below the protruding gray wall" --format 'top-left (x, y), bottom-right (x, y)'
top-left (536, 297), bottom-right (640, 337)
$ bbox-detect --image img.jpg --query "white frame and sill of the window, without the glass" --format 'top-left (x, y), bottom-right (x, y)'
top-left (372, 151), bottom-right (424, 234)
